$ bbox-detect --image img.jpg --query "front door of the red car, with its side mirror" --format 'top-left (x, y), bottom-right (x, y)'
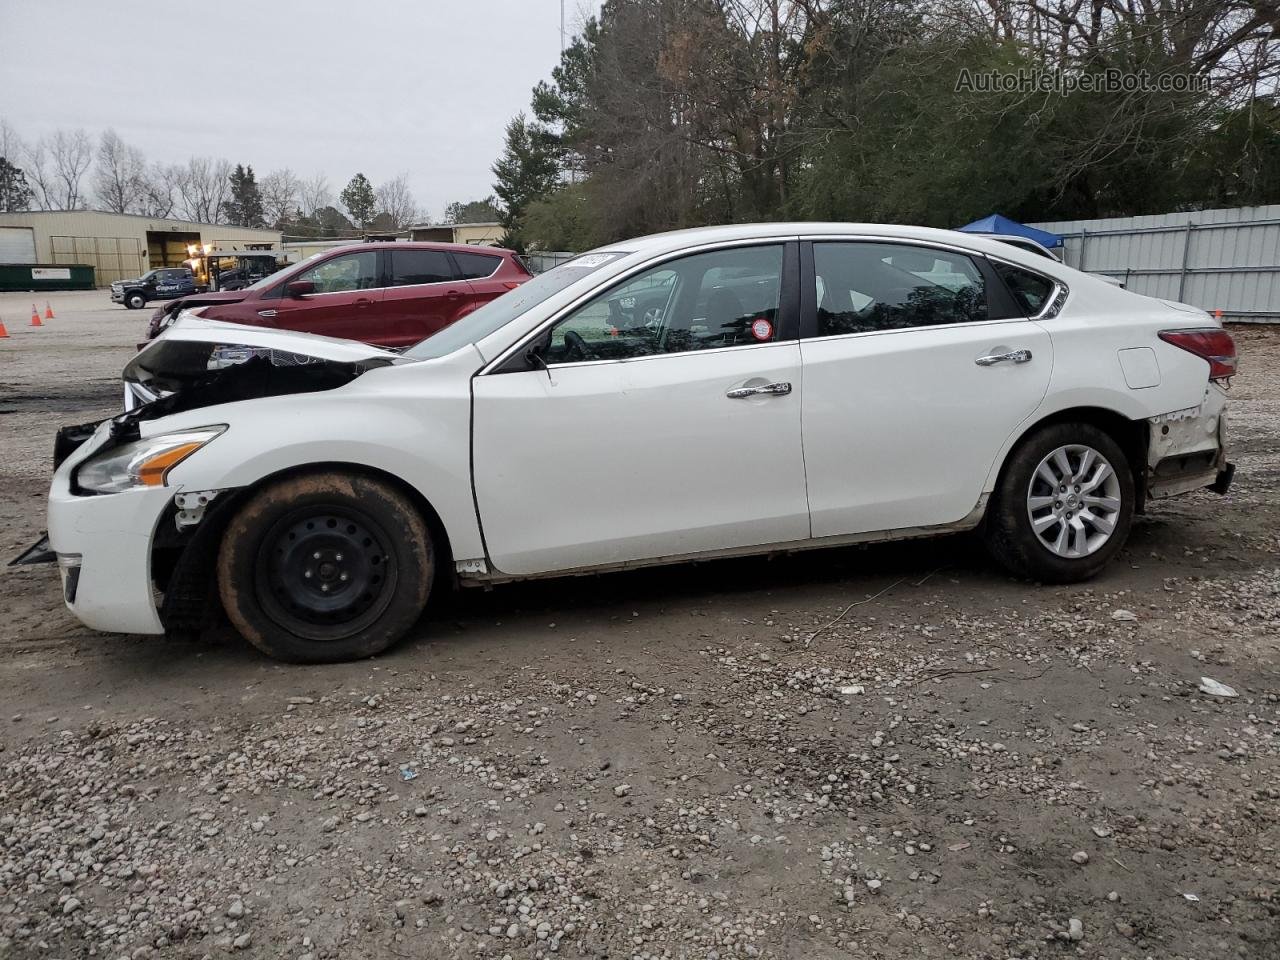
top-left (273, 248), bottom-right (392, 346)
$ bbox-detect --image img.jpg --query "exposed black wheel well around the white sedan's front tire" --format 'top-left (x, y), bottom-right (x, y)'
top-left (151, 461), bottom-right (457, 632)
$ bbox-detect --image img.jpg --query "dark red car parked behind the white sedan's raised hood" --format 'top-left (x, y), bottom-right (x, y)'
top-left (147, 243), bottom-right (531, 347)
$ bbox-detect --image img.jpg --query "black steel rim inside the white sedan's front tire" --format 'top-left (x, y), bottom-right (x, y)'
top-left (256, 504), bottom-right (397, 640)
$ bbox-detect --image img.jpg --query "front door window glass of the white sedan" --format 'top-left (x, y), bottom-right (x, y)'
top-left (543, 243), bottom-right (783, 364)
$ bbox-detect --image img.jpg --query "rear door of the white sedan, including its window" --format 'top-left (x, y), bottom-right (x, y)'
top-left (800, 241), bottom-right (1053, 538)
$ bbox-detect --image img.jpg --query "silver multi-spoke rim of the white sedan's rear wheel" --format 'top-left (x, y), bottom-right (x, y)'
top-left (1027, 443), bottom-right (1121, 558)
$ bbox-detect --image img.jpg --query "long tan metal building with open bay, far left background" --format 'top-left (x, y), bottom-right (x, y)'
top-left (0, 210), bottom-right (280, 287)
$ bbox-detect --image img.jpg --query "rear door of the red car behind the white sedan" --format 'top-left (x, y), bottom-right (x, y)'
top-left (379, 247), bottom-right (474, 347)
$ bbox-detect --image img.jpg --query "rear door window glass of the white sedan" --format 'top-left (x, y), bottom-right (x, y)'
top-left (813, 242), bottom-right (988, 337)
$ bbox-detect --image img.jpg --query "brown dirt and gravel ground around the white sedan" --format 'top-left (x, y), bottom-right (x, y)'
top-left (0, 293), bottom-right (1280, 960)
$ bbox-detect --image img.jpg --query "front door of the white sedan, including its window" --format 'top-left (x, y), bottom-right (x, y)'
top-left (472, 243), bottom-right (809, 576)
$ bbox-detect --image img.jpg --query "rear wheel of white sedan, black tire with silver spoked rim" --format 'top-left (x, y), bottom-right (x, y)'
top-left (986, 424), bottom-right (1134, 584)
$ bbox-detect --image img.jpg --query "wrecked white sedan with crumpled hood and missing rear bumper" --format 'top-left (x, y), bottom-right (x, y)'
top-left (35, 224), bottom-right (1235, 662)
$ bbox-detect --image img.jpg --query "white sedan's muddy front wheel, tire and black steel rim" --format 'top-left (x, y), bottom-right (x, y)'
top-left (218, 472), bottom-right (435, 663)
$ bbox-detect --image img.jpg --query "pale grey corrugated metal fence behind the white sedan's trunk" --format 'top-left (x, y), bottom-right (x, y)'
top-left (1033, 205), bottom-right (1280, 323)
